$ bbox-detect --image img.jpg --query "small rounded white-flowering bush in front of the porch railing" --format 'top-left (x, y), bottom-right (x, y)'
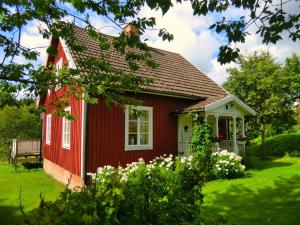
top-left (212, 150), bottom-right (245, 179)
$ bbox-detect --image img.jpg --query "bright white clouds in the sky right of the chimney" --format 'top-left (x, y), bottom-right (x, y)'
top-left (140, 2), bottom-right (300, 84)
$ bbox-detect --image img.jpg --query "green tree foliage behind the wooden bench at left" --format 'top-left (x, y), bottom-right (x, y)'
top-left (0, 99), bottom-right (40, 159)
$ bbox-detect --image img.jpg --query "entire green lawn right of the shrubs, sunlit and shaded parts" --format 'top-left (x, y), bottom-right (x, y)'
top-left (202, 157), bottom-right (300, 225)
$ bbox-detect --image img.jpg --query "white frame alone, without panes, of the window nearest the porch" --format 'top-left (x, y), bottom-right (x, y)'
top-left (125, 106), bottom-right (153, 151)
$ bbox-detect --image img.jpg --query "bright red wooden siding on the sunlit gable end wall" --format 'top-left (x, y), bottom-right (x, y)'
top-left (43, 39), bottom-right (82, 176)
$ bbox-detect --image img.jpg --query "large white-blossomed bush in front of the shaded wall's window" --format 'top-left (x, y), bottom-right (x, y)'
top-left (83, 155), bottom-right (204, 225)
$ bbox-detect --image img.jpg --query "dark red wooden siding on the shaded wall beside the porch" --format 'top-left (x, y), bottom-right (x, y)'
top-left (86, 94), bottom-right (195, 172)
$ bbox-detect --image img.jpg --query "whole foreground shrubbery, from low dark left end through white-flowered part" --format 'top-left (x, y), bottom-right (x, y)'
top-left (27, 156), bottom-right (203, 225)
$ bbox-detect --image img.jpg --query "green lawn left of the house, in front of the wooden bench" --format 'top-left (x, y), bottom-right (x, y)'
top-left (0, 161), bottom-right (64, 225)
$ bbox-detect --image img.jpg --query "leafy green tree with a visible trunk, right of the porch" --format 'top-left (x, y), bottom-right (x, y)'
top-left (224, 52), bottom-right (299, 156)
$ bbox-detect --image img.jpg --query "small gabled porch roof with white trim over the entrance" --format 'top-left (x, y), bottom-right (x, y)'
top-left (177, 94), bottom-right (256, 116)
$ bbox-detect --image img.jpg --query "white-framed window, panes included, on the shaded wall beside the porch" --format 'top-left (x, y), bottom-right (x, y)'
top-left (125, 106), bottom-right (153, 151)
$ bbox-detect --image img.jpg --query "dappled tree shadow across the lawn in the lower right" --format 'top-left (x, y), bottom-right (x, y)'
top-left (202, 176), bottom-right (300, 225)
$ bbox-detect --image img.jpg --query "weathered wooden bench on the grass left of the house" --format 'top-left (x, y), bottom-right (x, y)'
top-left (10, 139), bottom-right (41, 168)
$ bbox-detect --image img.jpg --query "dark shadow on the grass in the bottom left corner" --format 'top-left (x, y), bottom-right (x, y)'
top-left (0, 199), bottom-right (23, 225)
